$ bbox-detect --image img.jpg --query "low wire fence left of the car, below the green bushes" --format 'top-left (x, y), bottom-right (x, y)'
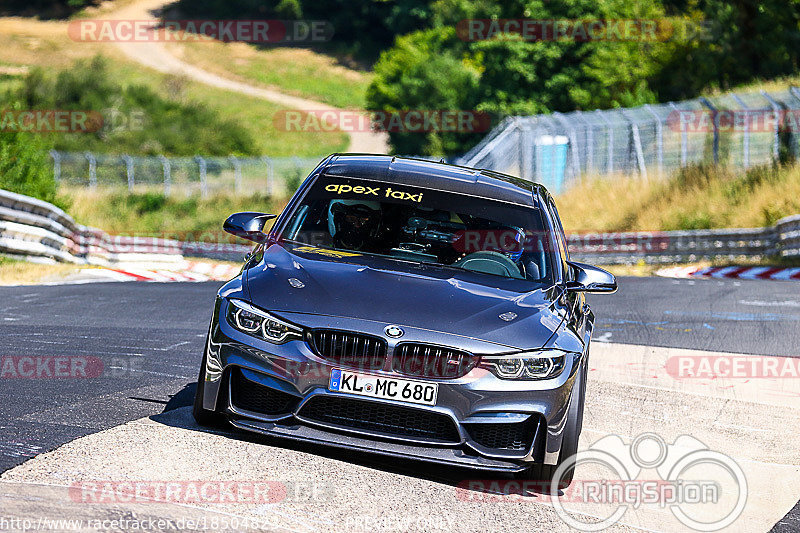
top-left (50, 150), bottom-right (321, 197)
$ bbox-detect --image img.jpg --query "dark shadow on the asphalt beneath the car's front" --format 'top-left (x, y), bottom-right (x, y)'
top-left (150, 383), bottom-right (548, 497)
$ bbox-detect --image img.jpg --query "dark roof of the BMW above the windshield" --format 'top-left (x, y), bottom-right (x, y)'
top-left (321, 154), bottom-right (547, 207)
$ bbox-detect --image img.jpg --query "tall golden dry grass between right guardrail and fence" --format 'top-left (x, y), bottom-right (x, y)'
top-left (558, 165), bottom-right (800, 232)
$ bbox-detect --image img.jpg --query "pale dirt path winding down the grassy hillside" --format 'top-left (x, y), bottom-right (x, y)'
top-left (104, 0), bottom-right (388, 154)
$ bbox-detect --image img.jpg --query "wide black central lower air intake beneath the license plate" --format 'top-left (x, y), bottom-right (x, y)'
top-left (298, 396), bottom-right (461, 444)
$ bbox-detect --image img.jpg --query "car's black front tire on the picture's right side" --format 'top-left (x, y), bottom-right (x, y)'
top-left (516, 365), bottom-right (586, 490)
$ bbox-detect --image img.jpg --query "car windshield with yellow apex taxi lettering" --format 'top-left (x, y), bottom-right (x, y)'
top-left (281, 176), bottom-right (552, 283)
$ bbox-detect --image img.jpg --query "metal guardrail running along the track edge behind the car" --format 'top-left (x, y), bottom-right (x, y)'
top-left (0, 190), bottom-right (800, 265)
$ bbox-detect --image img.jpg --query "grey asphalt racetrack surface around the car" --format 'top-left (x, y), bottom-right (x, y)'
top-left (0, 278), bottom-right (800, 531)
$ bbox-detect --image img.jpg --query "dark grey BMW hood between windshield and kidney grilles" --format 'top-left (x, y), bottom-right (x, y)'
top-left (246, 244), bottom-right (565, 349)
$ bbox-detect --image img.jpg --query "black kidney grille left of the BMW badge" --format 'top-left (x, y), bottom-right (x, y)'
top-left (311, 329), bottom-right (386, 370)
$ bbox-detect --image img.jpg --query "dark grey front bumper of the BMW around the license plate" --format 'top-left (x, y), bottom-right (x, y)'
top-left (203, 299), bottom-right (584, 472)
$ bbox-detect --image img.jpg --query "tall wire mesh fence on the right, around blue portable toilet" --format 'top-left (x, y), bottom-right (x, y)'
top-left (455, 87), bottom-right (800, 192)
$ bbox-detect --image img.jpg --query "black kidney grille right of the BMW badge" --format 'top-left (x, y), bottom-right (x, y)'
top-left (392, 343), bottom-right (478, 378)
